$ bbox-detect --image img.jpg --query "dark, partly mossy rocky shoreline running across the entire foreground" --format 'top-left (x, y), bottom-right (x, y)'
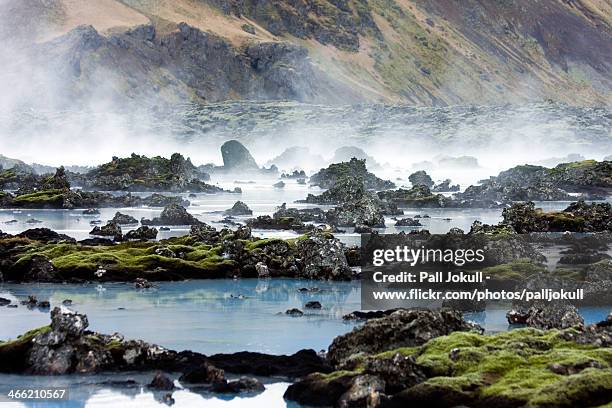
top-left (0, 306), bottom-right (612, 408)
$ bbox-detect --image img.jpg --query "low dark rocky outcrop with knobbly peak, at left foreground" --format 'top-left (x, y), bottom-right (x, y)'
top-left (0, 306), bottom-right (330, 382)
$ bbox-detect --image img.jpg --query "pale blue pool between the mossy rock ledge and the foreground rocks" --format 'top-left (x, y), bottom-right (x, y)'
top-left (0, 279), bottom-right (360, 354)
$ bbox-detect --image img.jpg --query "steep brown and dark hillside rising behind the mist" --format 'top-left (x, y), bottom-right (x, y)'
top-left (0, 0), bottom-right (612, 105)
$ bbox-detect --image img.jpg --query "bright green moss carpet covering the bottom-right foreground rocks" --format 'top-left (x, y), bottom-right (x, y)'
top-left (323, 328), bottom-right (612, 407)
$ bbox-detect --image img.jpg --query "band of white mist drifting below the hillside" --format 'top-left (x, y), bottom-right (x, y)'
top-left (0, 102), bottom-right (612, 185)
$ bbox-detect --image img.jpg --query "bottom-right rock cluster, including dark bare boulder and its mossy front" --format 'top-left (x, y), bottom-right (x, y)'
top-left (285, 309), bottom-right (612, 408)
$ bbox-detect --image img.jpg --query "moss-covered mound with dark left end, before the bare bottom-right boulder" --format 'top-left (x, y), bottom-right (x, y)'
top-left (285, 326), bottom-right (612, 408)
